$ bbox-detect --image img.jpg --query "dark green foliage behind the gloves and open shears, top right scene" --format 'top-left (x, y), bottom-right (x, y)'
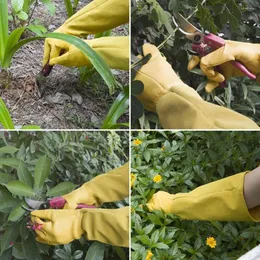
top-left (132, 0), bottom-right (260, 128)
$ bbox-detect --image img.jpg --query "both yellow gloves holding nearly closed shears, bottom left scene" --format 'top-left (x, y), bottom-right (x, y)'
top-left (31, 163), bottom-right (129, 247)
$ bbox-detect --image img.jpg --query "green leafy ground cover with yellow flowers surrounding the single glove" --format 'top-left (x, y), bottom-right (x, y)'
top-left (131, 131), bottom-right (260, 260)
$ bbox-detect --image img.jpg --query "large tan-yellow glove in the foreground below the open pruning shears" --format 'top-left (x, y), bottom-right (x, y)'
top-left (135, 44), bottom-right (259, 129)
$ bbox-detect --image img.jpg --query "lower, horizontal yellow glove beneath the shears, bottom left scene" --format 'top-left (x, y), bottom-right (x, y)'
top-left (31, 207), bottom-right (129, 247)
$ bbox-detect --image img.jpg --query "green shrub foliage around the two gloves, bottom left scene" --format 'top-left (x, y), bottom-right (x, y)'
top-left (0, 132), bottom-right (128, 260)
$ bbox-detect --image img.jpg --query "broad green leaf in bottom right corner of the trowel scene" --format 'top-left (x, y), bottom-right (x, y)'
top-left (102, 88), bottom-right (129, 129)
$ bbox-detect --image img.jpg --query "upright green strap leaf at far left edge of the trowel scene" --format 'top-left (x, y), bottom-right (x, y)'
top-left (0, 0), bottom-right (8, 62)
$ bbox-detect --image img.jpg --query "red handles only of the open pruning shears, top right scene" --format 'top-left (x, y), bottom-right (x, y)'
top-left (192, 33), bottom-right (256, 80)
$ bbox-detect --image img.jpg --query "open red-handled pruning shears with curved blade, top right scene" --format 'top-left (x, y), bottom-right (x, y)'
top-left (172, 13), bottom-right (256, 85)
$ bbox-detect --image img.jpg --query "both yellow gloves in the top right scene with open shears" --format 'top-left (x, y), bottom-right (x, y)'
top-left (135, 41), bottom-right (260, 129)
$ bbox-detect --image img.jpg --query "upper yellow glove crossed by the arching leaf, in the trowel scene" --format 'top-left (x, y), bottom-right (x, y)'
top-left (43, 0), bottom-right (129, 65)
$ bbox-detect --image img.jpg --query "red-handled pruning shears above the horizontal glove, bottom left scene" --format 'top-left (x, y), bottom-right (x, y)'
top-left (25, 197), bottom-right (96, 211)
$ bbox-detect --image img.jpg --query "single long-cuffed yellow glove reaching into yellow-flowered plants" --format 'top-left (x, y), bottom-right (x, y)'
top-left (147, 172), bottom-right (260, 221)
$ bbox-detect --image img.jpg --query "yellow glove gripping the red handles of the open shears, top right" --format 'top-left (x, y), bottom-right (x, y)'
top-left (188, 41), bottom-right (260, 93)
